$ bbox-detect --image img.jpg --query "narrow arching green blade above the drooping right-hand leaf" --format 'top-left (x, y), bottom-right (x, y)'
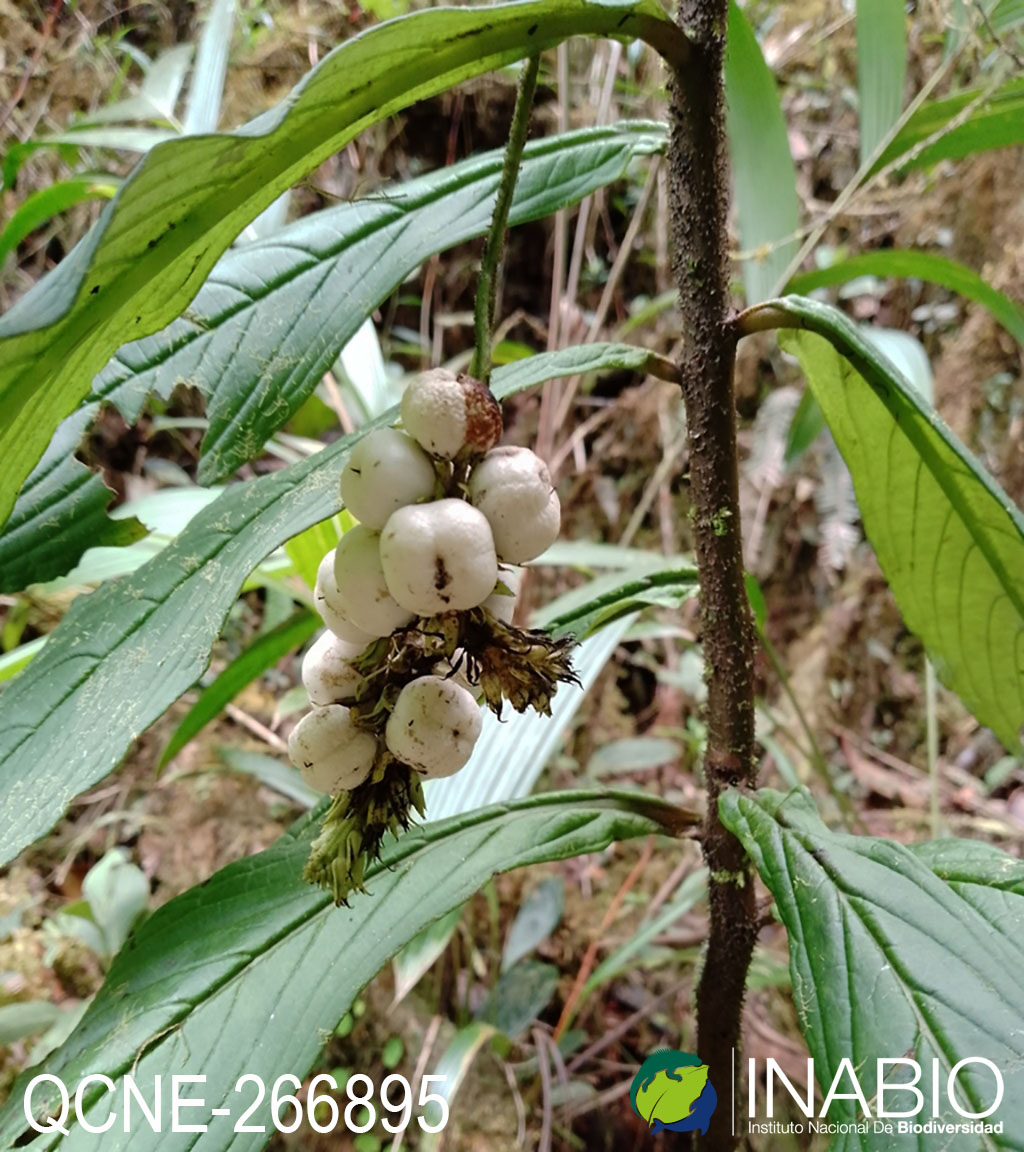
top-left (786, 248), bottom-right (1024, 344)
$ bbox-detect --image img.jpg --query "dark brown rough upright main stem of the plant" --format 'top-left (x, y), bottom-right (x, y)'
top-left (669, 0), bottom-right (757, 1152)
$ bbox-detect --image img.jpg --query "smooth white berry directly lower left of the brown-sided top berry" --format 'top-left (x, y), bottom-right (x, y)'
top-left (341, 429), bottom-right (437, 531)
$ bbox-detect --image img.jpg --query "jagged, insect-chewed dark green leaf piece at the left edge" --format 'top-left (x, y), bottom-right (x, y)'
top-left (0, 409), bottom-right (146, 592)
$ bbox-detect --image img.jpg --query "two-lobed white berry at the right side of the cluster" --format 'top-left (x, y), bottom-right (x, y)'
top-left (469, 447), bottom-right (562, 564)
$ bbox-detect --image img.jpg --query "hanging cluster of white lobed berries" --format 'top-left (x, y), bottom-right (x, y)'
top-left (288, 370), bottom-right (561, 795)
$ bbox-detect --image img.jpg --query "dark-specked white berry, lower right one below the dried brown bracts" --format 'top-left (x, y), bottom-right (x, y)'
top-left (385, 676), bottom-right (483, 778)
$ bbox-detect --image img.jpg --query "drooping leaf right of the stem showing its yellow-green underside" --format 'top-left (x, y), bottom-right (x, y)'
top-left (766, 296), bottom-right (1024, 749)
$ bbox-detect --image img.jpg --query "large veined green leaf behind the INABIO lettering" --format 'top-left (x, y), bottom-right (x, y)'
top-left (719, 791), bottom-right (1024, 1152)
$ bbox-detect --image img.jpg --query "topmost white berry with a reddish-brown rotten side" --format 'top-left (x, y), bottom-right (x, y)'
top-left (402, 369), bottom-right (501, 460)
